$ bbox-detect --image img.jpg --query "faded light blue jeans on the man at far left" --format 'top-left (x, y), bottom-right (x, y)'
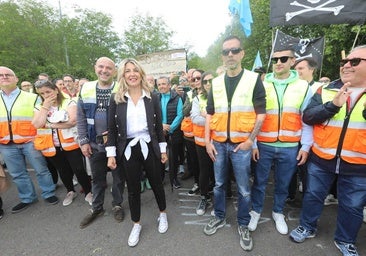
top-left (0, 142), bottom-right (55, 203)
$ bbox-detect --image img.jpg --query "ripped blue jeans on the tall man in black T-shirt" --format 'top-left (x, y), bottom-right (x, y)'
top-left (213, 141), bottom-right (251, 226)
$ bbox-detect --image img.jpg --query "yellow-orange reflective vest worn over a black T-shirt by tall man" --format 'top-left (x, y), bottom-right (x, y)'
top-left (210, 70), bottom-right (258, 143)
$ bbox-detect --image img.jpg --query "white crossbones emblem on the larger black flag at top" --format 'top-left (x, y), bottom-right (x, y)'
top-left (286, 0), bottom-right (344, 21)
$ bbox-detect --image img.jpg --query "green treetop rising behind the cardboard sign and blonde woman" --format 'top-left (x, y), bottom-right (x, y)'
top-left (121, 14), bottom-right (174, 57)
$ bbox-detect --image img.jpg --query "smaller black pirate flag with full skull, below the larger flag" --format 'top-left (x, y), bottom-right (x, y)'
top-left (271, 29), bottom-right (324, 70)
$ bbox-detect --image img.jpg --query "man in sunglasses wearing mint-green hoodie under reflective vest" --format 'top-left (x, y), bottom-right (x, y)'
top-left (249, 47), bottom-right (313, 235)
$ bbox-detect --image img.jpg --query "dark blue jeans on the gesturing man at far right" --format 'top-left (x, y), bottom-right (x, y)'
top-left (300, 162), bottom-right (366, 244)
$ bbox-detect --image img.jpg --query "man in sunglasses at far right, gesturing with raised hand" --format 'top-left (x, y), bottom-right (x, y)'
top-left (290, 45), bottom-right (366, 255)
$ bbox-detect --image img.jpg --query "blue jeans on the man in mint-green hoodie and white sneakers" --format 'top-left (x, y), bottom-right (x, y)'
top-left (252, 143), bottom-right (299, 213)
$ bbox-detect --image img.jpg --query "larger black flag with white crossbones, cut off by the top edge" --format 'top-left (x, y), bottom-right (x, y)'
top-left (270, 0), bottom-right (366, 27)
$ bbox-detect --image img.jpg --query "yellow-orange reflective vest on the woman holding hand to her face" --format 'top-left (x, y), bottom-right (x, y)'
top-left (34, 98), bottom-right (79, 157)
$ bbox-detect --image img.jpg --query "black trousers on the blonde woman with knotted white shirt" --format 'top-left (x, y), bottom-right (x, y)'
top-left (123, 143), bottom-right (166, 222)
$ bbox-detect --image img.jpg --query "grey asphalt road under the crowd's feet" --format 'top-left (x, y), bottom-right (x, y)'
top-left (0, 172), bottom-right (366, 256)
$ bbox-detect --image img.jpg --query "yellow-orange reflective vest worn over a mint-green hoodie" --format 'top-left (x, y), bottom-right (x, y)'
top-left (257, 79), bottom-right (309, 142)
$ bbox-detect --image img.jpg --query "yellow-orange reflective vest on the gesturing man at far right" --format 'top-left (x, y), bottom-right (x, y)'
top-left (312, 88), bottom-right (366, 164)
